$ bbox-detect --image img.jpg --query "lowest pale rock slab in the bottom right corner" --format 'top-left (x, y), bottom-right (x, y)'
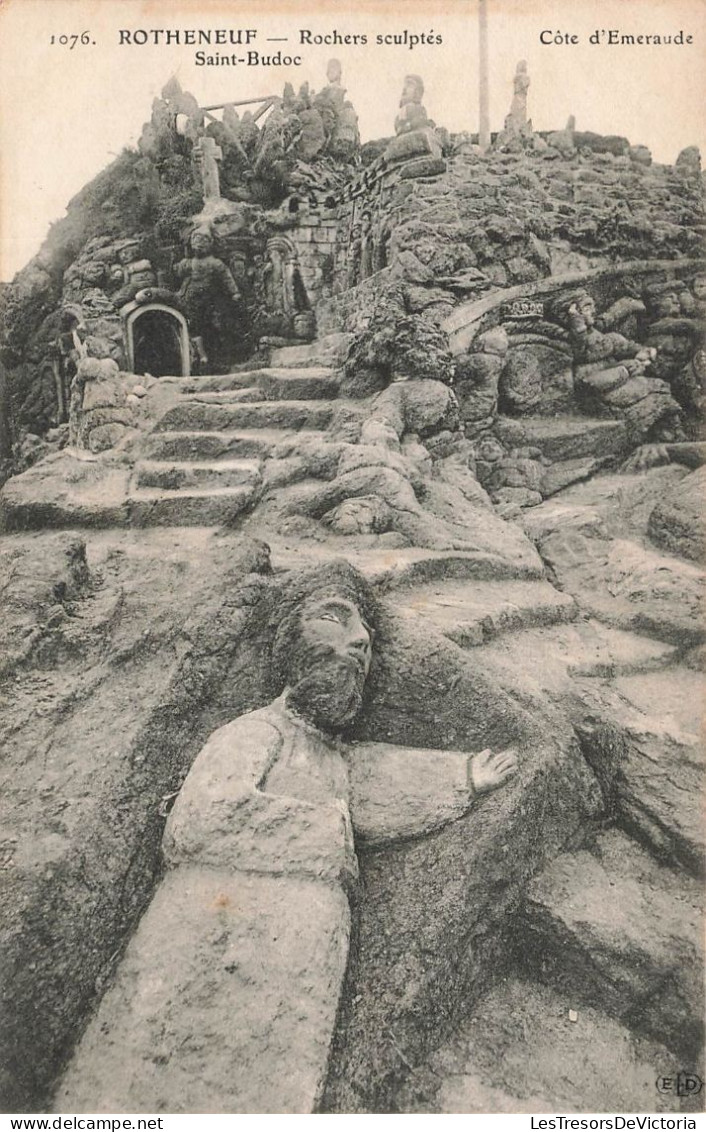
top-left (394, 977), bottom-right (698, 1114)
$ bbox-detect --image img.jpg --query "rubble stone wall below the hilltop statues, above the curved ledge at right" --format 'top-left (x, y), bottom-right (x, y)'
top-left (318, 131), bottom-right (705, 331)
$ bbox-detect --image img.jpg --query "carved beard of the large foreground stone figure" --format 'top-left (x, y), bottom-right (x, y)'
top-left (286, 652), bottom-right (365, 731)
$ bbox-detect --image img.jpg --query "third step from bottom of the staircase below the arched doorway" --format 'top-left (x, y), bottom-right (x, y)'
top-left (141, 428), bottom-right (321, 461)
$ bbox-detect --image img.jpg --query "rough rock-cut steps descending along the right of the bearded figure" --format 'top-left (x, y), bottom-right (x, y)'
top-left (380, 461), bottom-right (706, 1114)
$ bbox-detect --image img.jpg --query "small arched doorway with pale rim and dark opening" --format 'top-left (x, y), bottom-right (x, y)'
top-left (122, 302), bottom-right (191, 377)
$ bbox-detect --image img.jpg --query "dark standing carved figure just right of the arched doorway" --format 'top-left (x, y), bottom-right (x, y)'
top-left (177, 220), bottom-right (240, 366)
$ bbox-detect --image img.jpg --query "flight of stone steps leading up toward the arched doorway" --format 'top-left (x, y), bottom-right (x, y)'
top-left (128, 366), bottom-right (338, 526)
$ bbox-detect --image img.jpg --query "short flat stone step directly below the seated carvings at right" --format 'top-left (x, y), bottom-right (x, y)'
top-left (500, 417), bottom-right (626, 461)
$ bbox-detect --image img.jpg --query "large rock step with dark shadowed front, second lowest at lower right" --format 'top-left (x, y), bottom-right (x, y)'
top-left (517, 830), bottom-right (704, 1062)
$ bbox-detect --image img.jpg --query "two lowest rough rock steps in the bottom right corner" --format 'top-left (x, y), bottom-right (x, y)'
top-left (398, 830), bottom-right (704, 1113)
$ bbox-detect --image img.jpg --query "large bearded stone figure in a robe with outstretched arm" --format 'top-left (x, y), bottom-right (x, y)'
top-left (59, 561), bottom-right (516, 1113)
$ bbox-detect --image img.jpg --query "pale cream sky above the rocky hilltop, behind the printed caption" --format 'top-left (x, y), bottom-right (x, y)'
top-left (0, 0), bottom-right (706, 280)
